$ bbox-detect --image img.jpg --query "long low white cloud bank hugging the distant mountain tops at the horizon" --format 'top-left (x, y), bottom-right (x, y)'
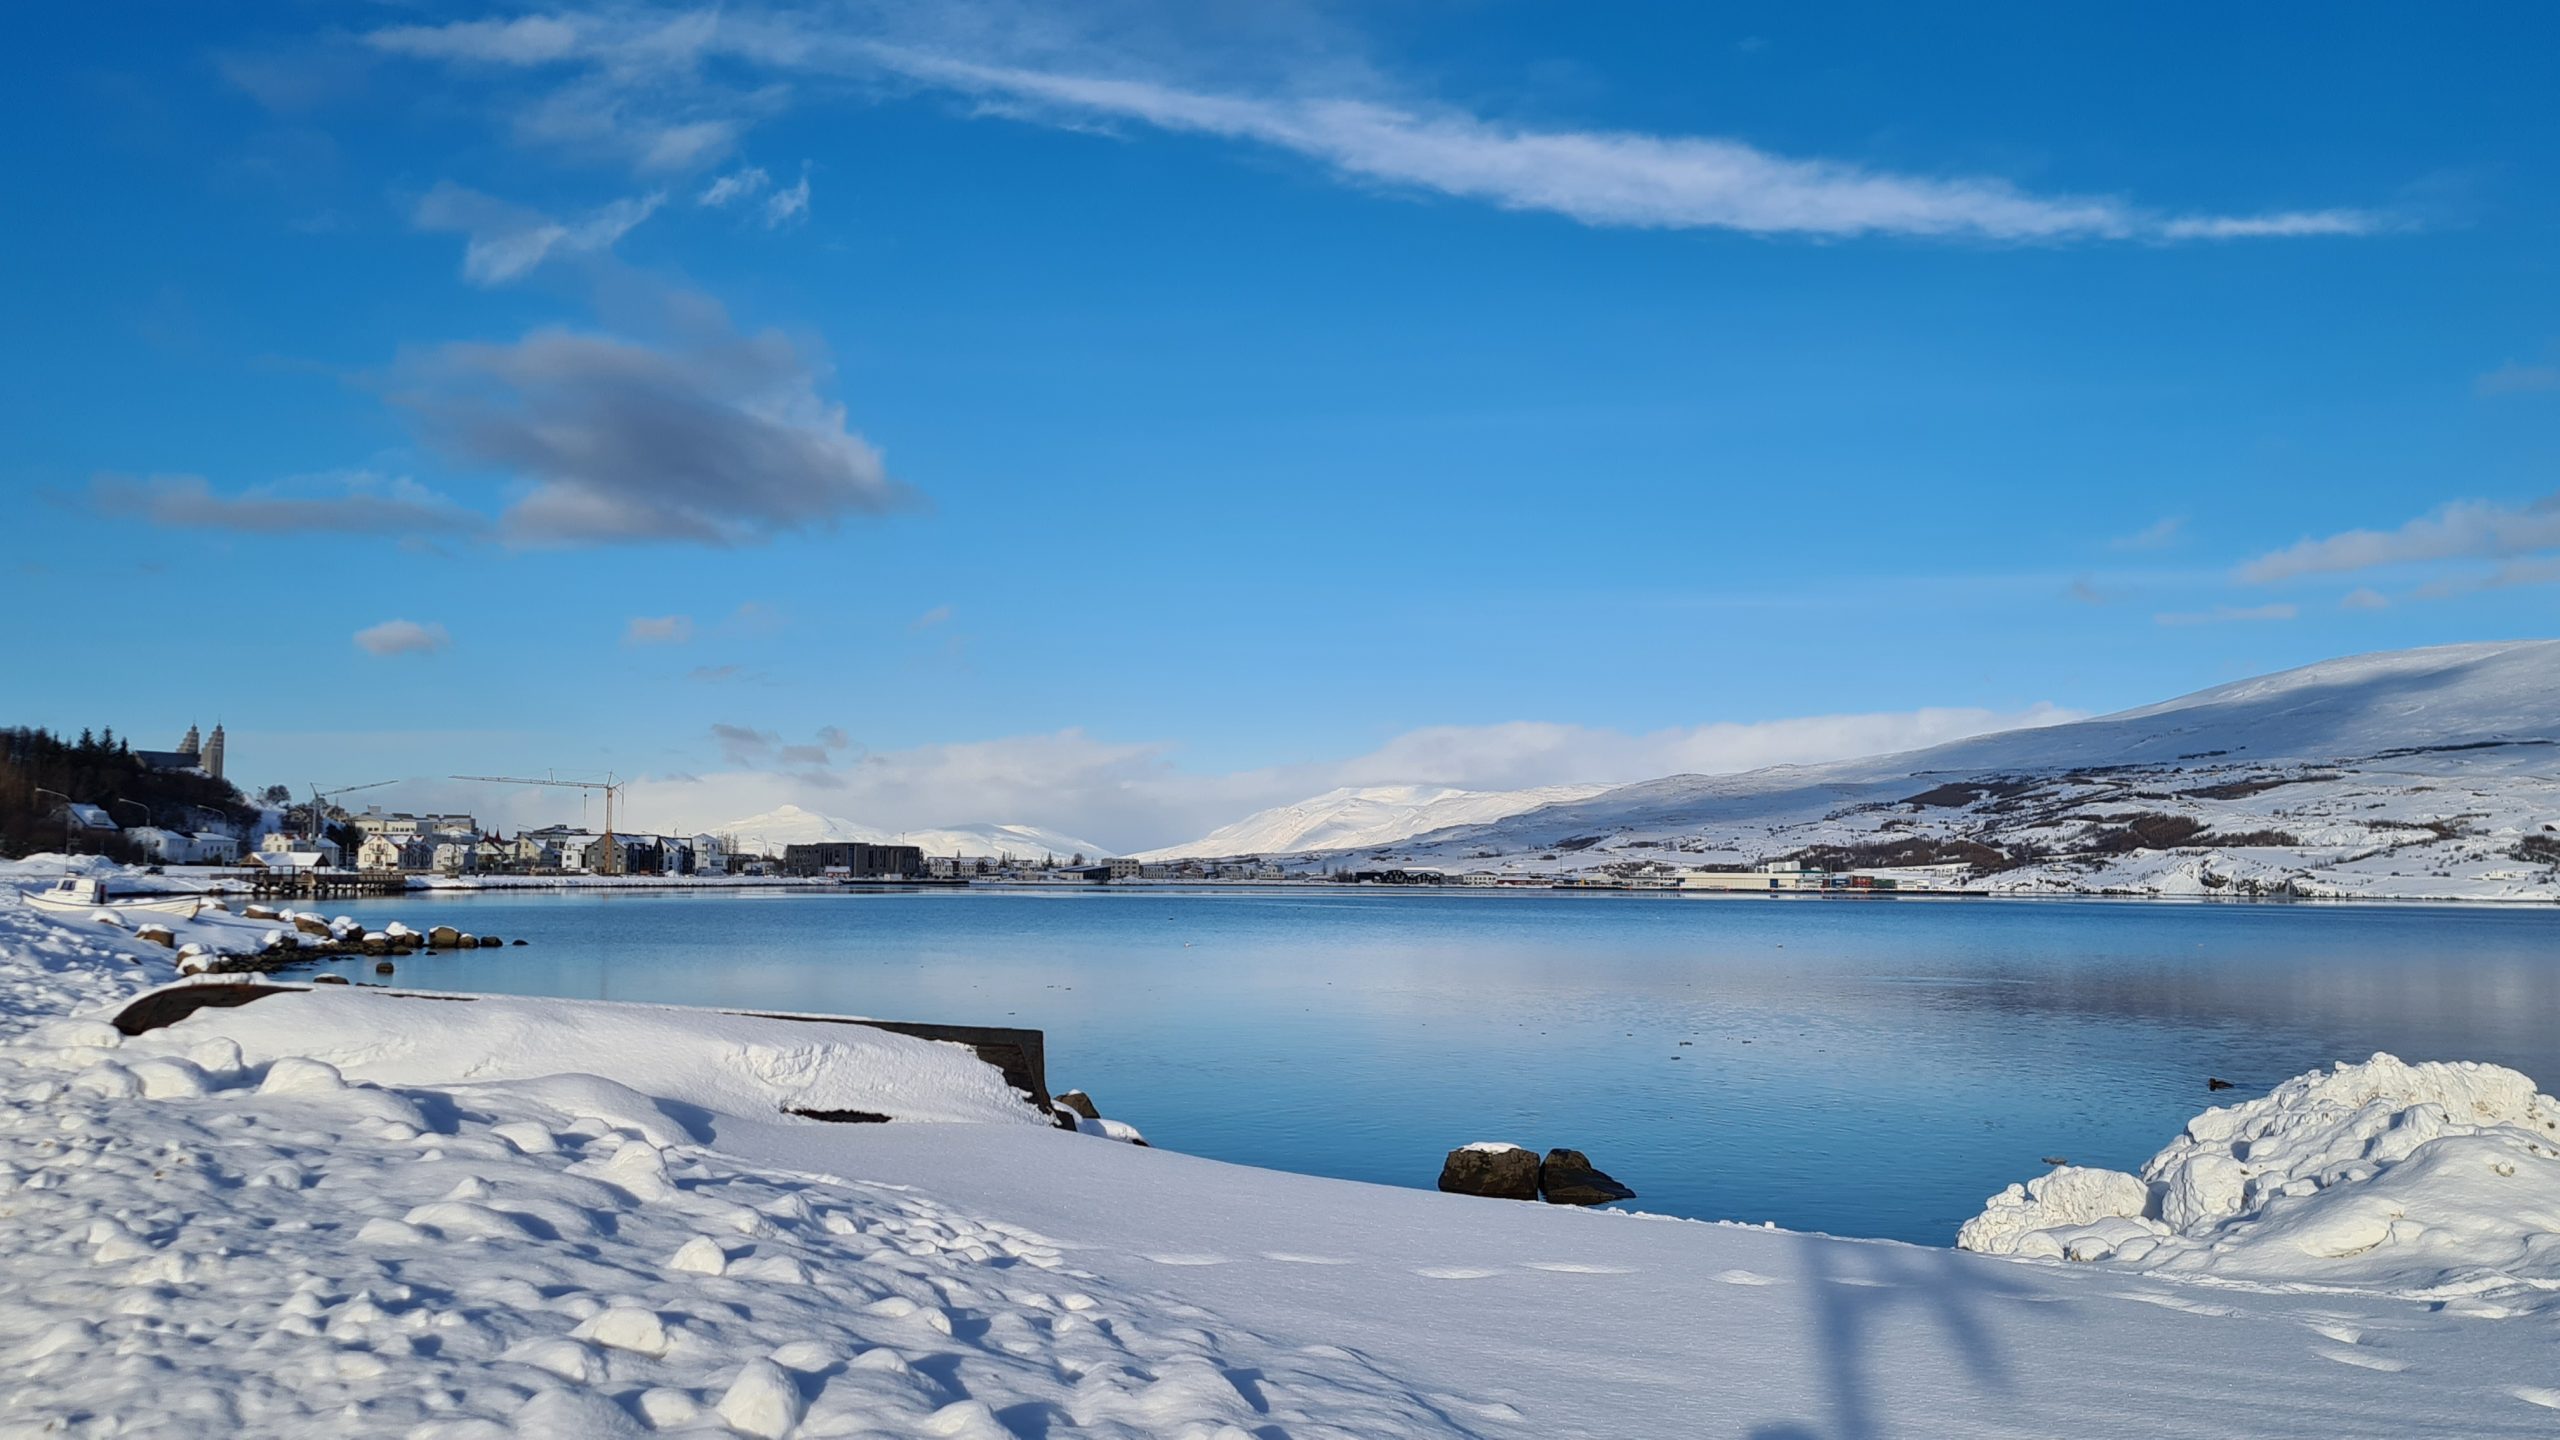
top-left (632, 705), bottom-right (2079, 851)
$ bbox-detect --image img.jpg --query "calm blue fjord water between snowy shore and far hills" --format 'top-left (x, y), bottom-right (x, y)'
top-left (309, 889), bottom-right (2560, 1245)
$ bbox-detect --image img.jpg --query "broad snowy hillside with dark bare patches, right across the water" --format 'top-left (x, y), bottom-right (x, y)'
top-left (1290, 641), bottom-right (2560, 899)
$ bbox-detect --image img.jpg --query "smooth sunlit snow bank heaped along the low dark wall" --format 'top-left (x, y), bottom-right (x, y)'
top-left (128, 986), bottom-right (1047, 1138)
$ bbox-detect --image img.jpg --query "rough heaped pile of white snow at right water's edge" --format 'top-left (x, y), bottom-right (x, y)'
top-left (1956, 1056), bottom-right (2560, 1294)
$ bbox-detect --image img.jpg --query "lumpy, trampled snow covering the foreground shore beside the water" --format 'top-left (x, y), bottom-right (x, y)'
top-left (0, 855), bottom-right (2560, 1440)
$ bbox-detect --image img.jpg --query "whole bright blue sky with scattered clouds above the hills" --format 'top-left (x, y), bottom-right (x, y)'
top-left (0, 3), bottom-right (2560, 848)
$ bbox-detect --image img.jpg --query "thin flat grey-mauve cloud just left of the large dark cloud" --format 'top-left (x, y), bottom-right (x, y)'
top-left (90, 471), bottom-right (489, 538)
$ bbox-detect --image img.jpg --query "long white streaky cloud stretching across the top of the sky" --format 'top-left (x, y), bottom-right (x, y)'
top-left (369, 8), bottom-right (2388, 243)
